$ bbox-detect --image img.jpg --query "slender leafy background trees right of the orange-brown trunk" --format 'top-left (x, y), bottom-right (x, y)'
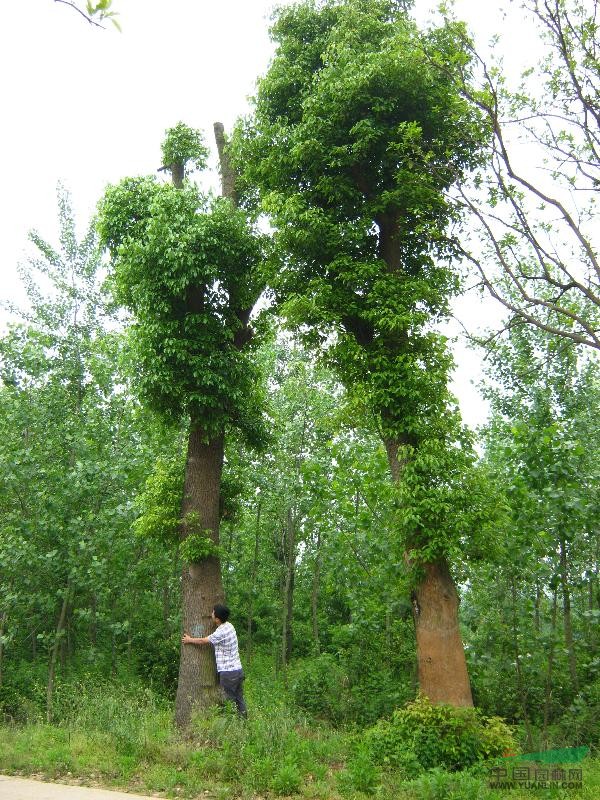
top-left (462, 321), bottom-right (600, 724)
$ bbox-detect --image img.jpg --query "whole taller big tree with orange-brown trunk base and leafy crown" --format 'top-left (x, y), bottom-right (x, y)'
top-left (237, 0), bottom-right (482, 705)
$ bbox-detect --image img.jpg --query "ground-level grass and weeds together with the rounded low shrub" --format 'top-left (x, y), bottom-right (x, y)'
top-left (0, 657), bottom-right (600, 800)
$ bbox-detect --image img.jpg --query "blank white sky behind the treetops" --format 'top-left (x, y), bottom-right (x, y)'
top-left (0, 0), bottom-right (527, 425)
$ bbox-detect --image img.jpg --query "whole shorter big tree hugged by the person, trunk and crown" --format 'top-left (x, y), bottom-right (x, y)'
top-left (99, 123), bottom-right (263, 726)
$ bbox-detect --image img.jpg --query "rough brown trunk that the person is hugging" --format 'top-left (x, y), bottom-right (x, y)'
top-left (175, 425), bottom-right (224, 728)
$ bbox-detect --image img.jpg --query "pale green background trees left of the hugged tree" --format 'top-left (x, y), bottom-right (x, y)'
top-left (0, 189), bottom-right (178, 720)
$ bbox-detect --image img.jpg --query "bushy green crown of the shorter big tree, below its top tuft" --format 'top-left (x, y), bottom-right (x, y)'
top-left (98, 170), bottom-right (264, 443)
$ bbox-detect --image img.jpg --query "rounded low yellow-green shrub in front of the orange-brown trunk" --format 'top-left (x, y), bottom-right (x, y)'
top-left (364, 695), bottom-right (516, 771)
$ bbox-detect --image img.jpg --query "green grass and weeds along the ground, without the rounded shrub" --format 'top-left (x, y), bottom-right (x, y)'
top-left (0, 672), bottom-right (600, 800)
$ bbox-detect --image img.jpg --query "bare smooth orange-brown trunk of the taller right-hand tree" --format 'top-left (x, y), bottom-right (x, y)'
top-left (385, 440), bottom-right (473, 706)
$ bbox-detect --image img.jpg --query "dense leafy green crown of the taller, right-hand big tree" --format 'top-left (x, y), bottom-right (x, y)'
top-left (237, 2), bottom-right (488, 434)
